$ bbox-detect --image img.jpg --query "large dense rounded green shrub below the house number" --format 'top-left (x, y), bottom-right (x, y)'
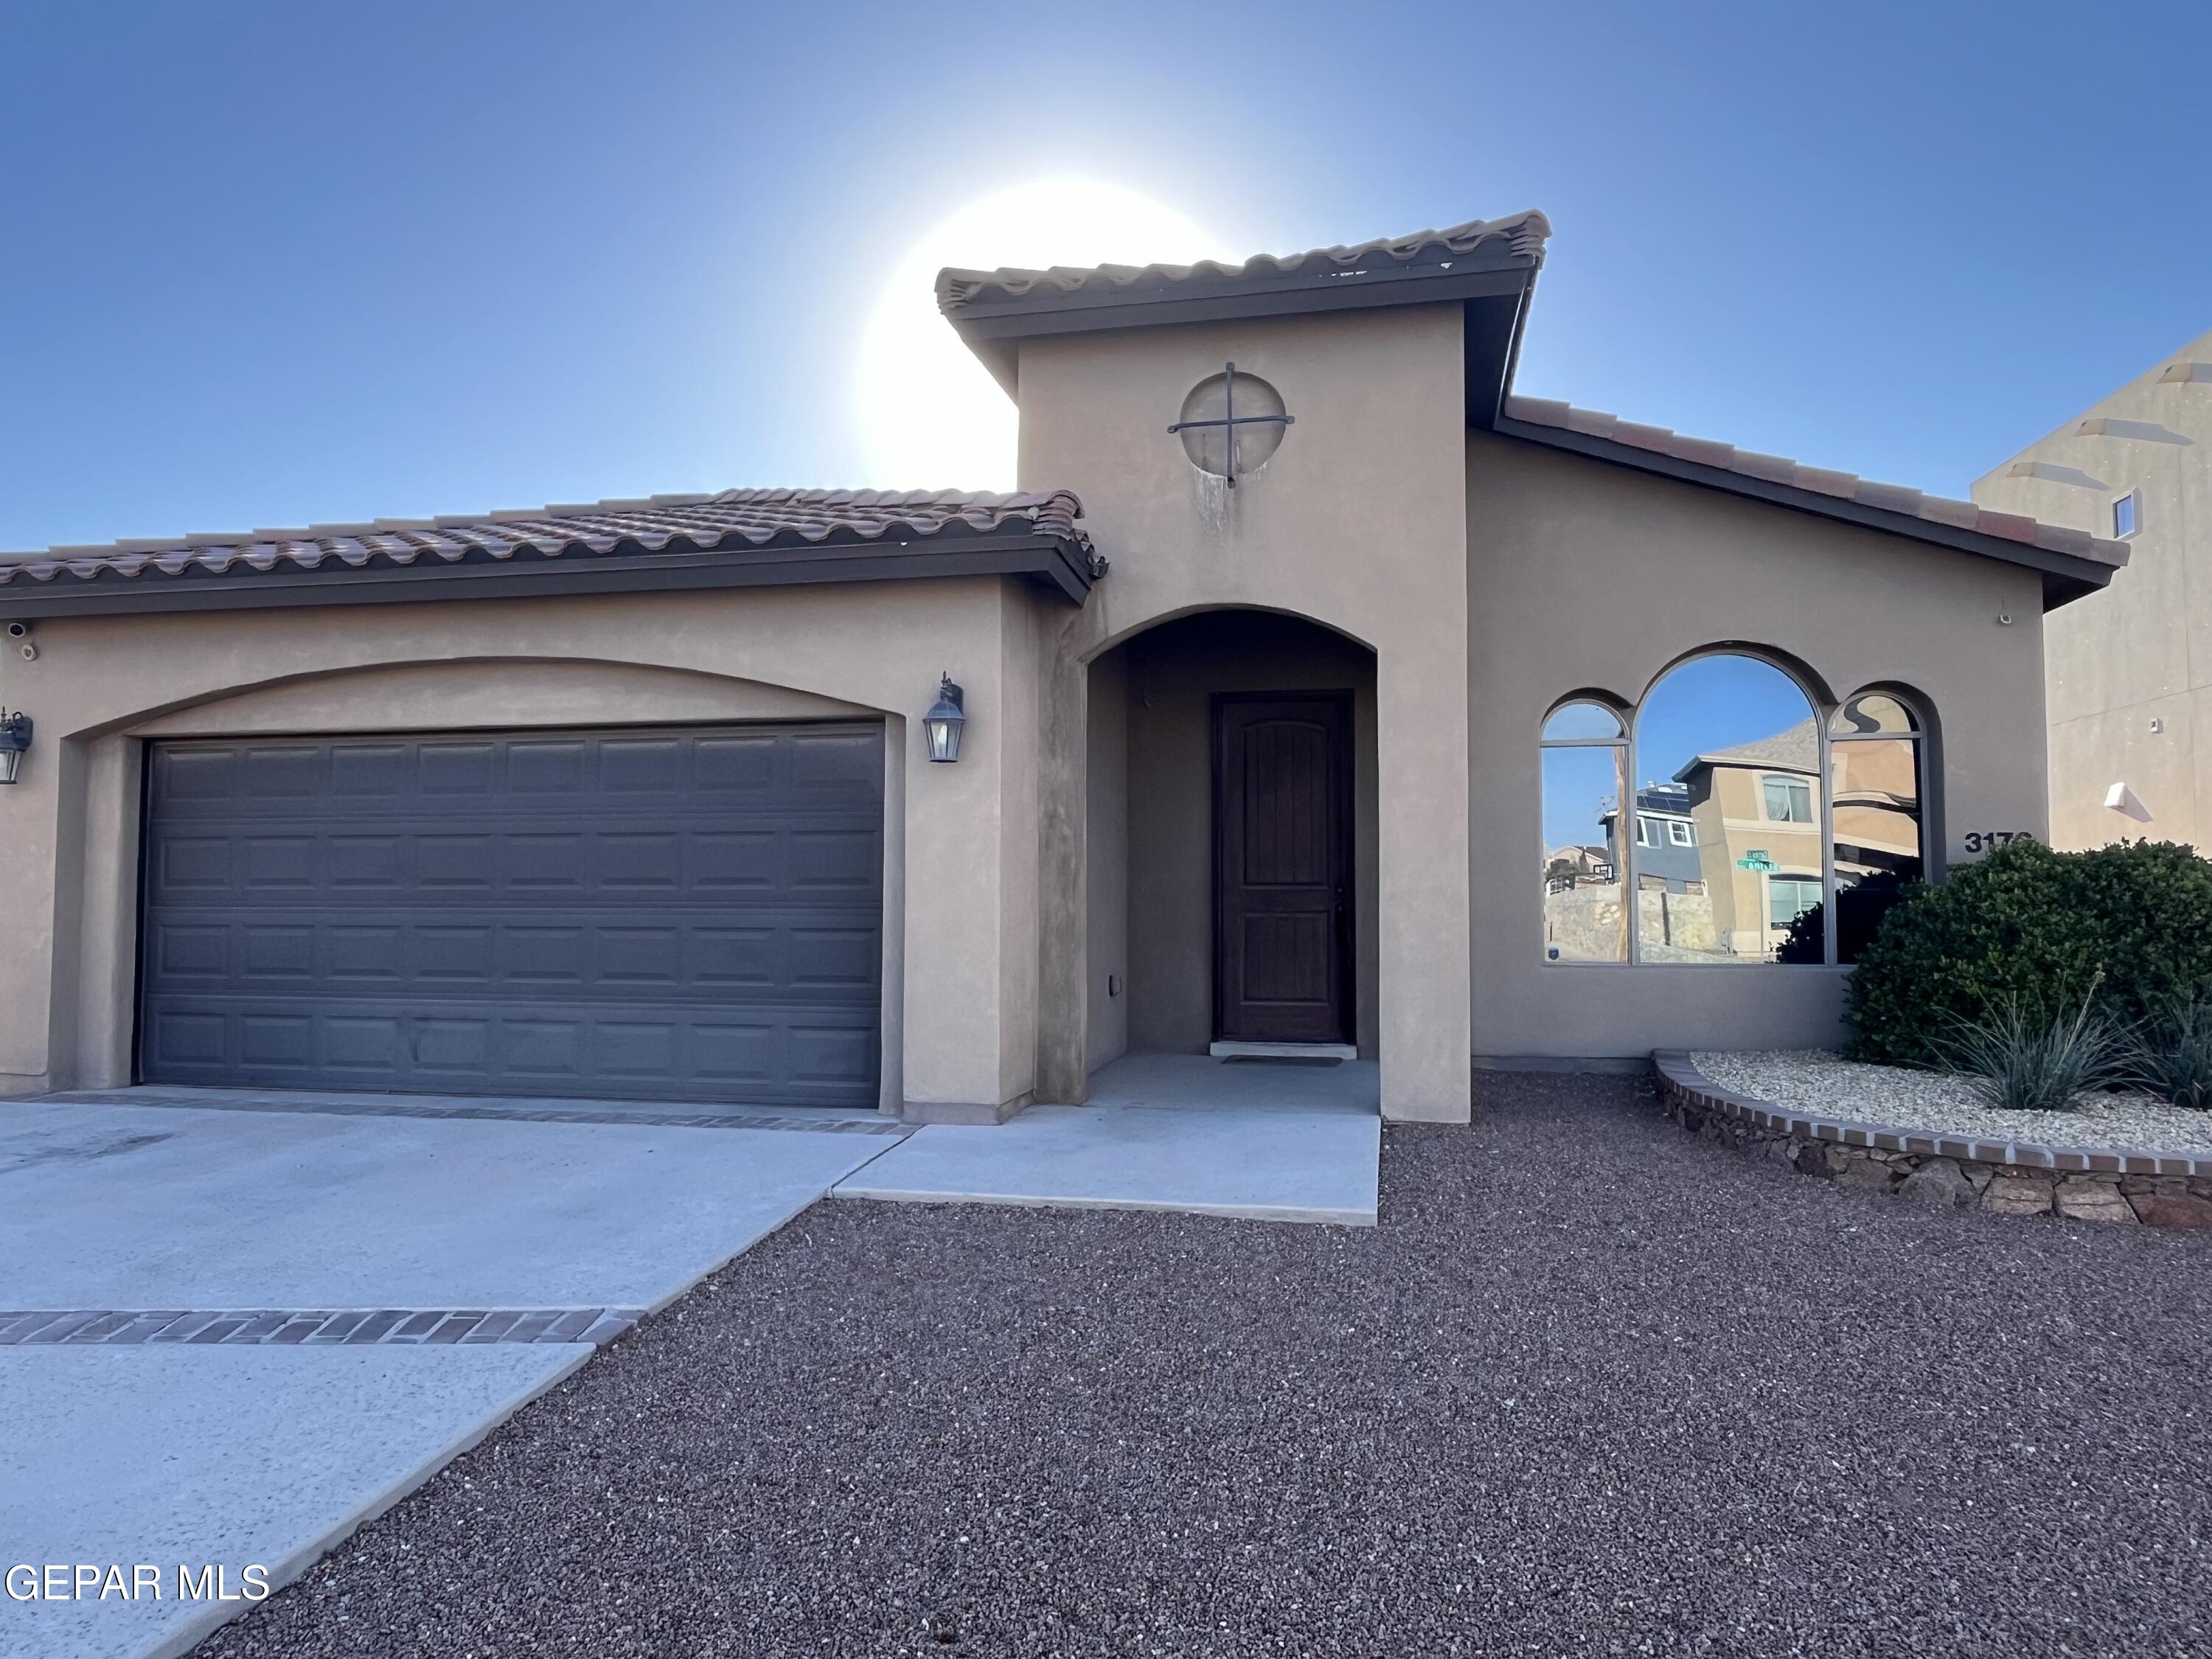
top-left (1845, 841), bottom-right (2212, 1066)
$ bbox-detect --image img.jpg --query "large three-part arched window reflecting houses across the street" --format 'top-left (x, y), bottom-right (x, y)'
top-left (1542, 650), bottom-right (1927, 964)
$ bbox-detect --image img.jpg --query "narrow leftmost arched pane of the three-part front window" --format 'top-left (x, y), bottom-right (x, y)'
top-left (1542, 699), bottom-right (1628, 962)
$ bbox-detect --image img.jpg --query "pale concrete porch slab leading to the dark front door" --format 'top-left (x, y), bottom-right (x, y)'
top-left (832, 1055), bottom-right (1382, 1228)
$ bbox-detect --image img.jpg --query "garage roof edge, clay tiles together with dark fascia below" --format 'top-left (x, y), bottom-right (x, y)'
top-left (0, 489), bottom-right (1106, 619)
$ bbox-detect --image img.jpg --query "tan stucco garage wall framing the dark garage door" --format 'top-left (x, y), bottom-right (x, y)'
top-left (0, 577), bottom-right (1046, 1115)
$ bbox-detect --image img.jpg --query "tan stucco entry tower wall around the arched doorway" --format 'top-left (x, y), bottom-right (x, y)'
top-left (1020, 305), bottom-right (1469, 1121)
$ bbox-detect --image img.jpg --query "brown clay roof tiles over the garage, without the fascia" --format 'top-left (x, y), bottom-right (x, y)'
top-left (0, 489), bottom-right (1088, 586)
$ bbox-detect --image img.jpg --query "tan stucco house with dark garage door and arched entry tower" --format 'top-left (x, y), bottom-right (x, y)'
top-left (0, 212), bottom-right (2126, 1121)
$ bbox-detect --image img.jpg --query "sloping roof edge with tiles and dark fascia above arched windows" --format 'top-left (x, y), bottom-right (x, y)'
top-left (1495, 398), bottom-right (2128, 611)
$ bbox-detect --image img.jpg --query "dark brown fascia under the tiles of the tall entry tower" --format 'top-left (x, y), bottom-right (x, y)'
top-left (949, 254), bottom-right (1535, 396)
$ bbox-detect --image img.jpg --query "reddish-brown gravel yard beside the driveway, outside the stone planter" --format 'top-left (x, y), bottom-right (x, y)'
top-left (201, 1075), bottom-right (2212, 1659)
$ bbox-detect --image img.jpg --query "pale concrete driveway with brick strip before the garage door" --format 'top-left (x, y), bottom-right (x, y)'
top-left (0, 1091), bottom-right (905, 1659)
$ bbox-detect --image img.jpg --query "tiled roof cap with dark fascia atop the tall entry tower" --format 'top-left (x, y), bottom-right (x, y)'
top-left (938, 212), bottom-right (1551, 427)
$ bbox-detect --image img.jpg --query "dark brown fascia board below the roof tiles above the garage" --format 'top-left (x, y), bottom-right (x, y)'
top-left (0, 535), bottom-right (1097, 622)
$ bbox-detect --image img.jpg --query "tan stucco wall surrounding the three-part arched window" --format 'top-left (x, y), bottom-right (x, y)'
top-left (1467, 434), bottom-right (2046, 1057)
